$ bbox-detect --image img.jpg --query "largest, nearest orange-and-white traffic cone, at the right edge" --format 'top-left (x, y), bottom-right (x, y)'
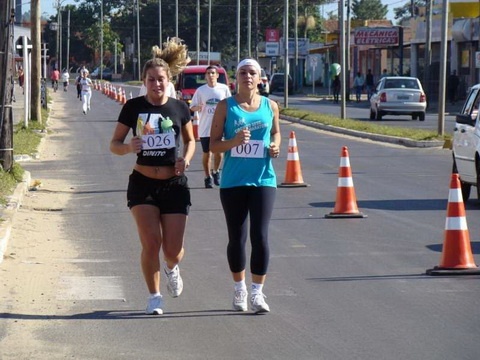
top-left (427, 174), bottom-right (480, 275)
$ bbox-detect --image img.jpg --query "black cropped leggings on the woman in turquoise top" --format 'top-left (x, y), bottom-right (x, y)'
top-left (220, 186), bottom-right (276, 275)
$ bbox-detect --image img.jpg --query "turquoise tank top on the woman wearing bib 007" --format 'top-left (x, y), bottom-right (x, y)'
top-left (220, 96), bottom-right (277, 188)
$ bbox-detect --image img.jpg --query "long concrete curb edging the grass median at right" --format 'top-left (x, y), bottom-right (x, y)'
top-left (280, 115), bottom-right (445, 148)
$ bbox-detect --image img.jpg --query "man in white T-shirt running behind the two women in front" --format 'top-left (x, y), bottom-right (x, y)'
top-left (190, 65), bottom-right (232, 189)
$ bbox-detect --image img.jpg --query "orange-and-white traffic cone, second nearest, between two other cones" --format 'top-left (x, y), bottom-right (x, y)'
top-left (325, 146), bottom-right (367, 218)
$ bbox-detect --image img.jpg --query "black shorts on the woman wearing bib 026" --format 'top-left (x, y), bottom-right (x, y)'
top-left (127, 170), bottom-right (192, 215)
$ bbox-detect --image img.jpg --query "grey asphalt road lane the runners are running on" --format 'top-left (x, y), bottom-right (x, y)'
top-left (0, 83), bottom-right (480, 360)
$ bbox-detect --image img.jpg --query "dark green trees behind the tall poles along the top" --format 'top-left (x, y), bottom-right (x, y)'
top-left (45, 0), bottom-right (338, 71)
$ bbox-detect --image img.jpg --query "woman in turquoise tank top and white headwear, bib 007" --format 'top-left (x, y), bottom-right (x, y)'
top-left (210, 59), bottom-right (281, 313)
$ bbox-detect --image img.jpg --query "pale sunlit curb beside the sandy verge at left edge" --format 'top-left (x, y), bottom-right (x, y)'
top-left (0, 171), bottom-right (31, 264)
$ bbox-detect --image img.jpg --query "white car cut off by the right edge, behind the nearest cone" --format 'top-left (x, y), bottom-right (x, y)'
top-left (452, 84), bottom-right (480, 201)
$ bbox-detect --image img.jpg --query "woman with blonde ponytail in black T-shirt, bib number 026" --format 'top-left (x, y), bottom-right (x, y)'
top-left (110, 38), bottom-right (195, 315)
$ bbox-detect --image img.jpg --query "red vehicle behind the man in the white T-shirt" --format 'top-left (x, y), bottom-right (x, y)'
top-left (175, 65), bottom-right (231, 106)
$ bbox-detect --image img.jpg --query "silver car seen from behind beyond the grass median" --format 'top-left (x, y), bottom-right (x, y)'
top-left (370, 76), bottom-right (427, 121)
